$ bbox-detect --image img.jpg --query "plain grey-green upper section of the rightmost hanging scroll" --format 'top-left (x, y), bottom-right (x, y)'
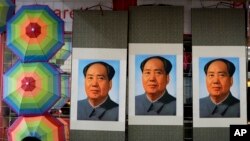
top-left (191, 8), bottom-right (246, 46)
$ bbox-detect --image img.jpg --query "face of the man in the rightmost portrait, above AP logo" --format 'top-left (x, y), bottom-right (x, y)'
top-left (206, 61), bottom-right (233, 97)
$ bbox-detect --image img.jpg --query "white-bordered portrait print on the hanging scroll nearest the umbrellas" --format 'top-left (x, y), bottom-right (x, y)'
top-left (70, 48), bottom-right (127, 131)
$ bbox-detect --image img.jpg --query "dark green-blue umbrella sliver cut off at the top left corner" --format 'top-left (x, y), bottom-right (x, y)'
top-left (0, 0), bottom-right (15, 33)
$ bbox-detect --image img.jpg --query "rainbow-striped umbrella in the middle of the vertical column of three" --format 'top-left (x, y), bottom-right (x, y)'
top-left (3, 61), bottom-right (61, 115)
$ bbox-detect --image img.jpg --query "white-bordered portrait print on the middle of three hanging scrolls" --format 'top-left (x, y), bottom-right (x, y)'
top-left (128, 43), bottom-right (183, 125)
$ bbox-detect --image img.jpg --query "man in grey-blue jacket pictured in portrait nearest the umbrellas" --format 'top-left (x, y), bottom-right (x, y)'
top-left (77, 61), bottom-right (119, 121)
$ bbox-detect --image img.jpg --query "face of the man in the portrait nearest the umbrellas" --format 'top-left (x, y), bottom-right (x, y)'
top-left (85, 64), bottom-right (112, 101)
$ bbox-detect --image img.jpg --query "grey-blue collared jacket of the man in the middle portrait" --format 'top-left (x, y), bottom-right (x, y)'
top-left (135, 90), bottom-right (176, 115)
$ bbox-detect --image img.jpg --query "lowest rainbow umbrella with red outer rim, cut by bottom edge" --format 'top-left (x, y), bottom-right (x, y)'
top-left (8, 115), bottom-right (65, 141)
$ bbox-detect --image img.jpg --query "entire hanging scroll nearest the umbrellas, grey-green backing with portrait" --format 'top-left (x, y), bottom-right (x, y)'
top-left (70, 10), bottom-right (128, 141)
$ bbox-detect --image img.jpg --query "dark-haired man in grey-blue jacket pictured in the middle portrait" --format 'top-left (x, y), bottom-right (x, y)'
top-left (135, 56), bottom-right (176, 115)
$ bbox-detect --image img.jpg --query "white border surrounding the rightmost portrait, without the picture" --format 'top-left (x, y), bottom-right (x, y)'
top-left (192, 46), bottom-right (247, 127)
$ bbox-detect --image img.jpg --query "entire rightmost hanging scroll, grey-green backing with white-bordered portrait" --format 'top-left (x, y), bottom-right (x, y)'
top-left (192, 8), bottom-right (247, 141)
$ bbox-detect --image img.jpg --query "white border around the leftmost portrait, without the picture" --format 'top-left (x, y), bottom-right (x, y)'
top-left (70, 47), bottom-right (127, 131)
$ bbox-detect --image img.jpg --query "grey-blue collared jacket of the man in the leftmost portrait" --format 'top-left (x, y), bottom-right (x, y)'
top-left (77, 97), bottom-right (119, 121)
